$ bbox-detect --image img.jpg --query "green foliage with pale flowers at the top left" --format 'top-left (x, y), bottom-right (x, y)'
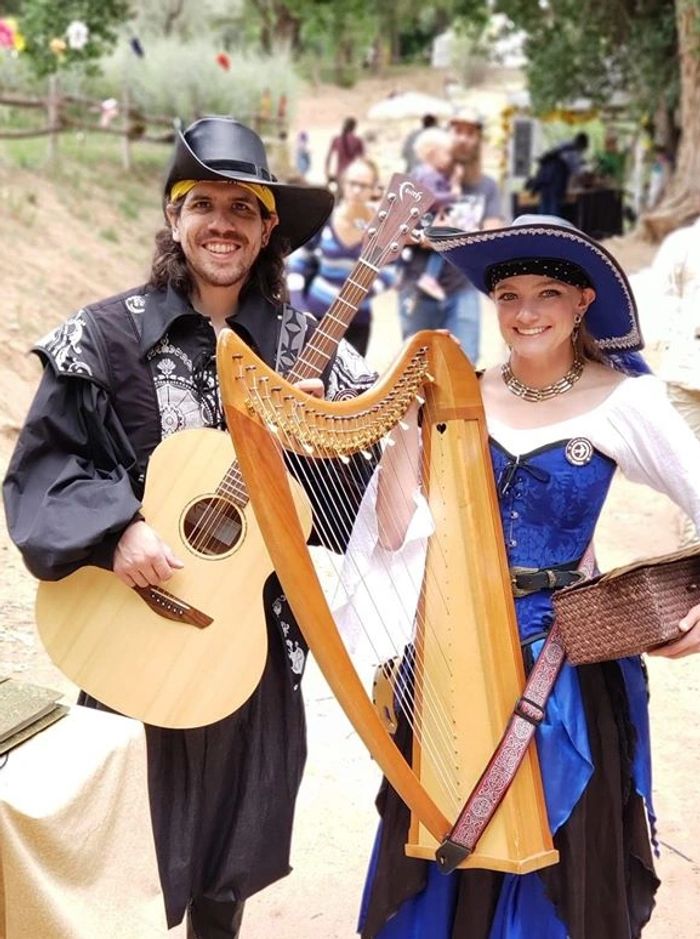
top-left (18, 0), bottom-right (129, 76)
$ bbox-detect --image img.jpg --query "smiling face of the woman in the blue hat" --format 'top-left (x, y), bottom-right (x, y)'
top-left (491, 274), bottom-right (595, 357)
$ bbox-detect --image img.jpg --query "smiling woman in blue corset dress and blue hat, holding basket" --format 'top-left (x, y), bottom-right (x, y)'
top-left (360, 216), bottom-right (700, 939)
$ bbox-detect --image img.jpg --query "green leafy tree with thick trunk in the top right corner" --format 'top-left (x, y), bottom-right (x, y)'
top-left (496, 0), bottom-right (700, 233)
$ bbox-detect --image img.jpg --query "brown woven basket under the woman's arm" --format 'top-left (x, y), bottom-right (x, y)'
top-left (552, 546), bottom-right (700, 665)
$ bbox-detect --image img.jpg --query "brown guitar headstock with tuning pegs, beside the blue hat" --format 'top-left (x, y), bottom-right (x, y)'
top-left (362, 173), bottom-right (435, 267)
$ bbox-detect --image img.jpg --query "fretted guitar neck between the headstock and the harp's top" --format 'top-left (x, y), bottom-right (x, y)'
top-left (286, 257), bottom-right (379, 384)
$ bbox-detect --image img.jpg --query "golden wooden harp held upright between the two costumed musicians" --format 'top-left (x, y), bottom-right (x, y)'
top-left (218, 330), bottom-right (558, 873)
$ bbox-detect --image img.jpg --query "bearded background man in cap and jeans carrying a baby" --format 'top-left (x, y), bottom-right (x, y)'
top-left (399, 109), bottom-right (504, 364)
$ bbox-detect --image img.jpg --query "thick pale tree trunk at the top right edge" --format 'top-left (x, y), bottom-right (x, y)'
top-left (641, 0), bottom-right (700, 241)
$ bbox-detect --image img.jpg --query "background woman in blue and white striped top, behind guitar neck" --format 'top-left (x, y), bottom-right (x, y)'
top-left (287, 157), bottom-right (394, 355)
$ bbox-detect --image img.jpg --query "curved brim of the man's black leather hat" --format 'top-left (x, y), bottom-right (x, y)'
top-left (164, 133), bottom-right (334, 251)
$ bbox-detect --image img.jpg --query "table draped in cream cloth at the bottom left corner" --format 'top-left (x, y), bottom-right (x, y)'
top-left (0, 705), bottom-right (167, 939)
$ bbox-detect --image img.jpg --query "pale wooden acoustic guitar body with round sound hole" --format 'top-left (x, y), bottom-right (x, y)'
top-left (36, 429), bottom-right (311, 728)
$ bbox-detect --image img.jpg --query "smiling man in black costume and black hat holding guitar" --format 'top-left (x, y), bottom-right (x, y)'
top-left (4, 118), bottom-right (373, 939)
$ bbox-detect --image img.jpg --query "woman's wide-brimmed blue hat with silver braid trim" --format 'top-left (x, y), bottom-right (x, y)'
top-left (428, 215), bottom-right (644, 352)
